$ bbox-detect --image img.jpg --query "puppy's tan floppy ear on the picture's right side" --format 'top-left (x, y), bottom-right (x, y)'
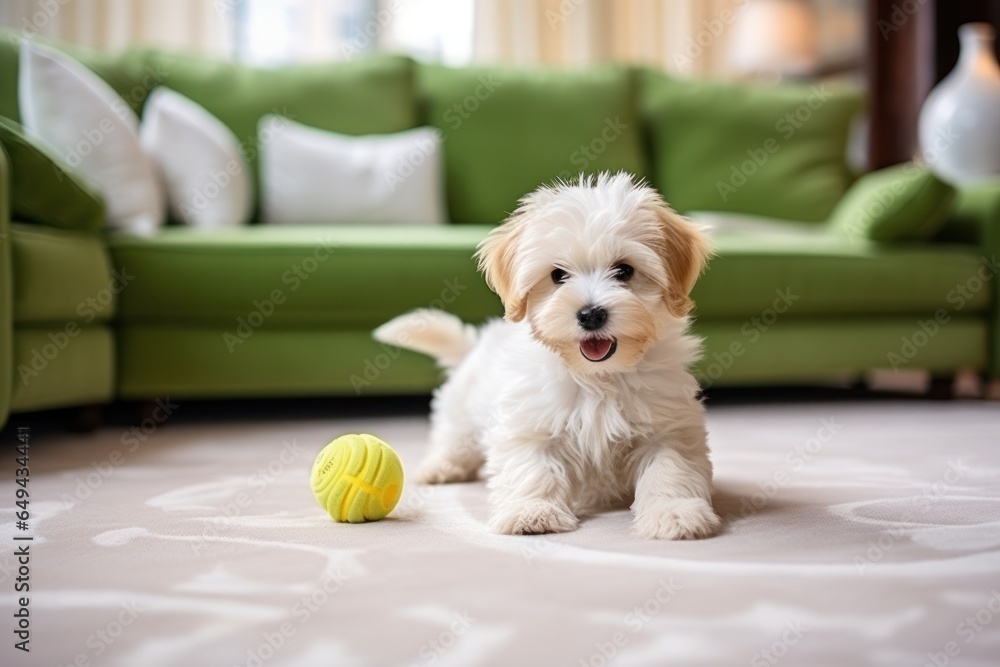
top-left (655, 200), bottom-right (712, 317)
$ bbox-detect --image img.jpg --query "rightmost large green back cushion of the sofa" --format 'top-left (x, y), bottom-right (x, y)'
top-left (642, 71), bottom-right (861, 222)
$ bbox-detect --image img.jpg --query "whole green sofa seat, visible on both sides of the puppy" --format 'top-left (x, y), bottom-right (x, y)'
top-left (111, 225), bottom-right (989, 334)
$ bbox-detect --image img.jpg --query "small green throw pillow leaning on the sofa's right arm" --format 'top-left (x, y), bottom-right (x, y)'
top-left (830, 163), bottom-right (955, 241)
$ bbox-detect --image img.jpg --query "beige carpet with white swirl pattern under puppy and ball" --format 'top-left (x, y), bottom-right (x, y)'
top-left (0, 402), bottom-right (1000, 667)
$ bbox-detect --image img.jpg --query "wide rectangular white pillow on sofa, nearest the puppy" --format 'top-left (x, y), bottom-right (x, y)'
top-left (258, 115), bottom-right (446, 224)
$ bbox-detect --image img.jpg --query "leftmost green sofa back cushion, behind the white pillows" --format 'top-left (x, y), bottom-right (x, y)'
top-left (0, 31), bottom-right (417, 223)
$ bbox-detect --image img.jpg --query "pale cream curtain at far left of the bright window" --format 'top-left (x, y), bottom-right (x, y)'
top-left (0, 0), bottom-right (230, 55)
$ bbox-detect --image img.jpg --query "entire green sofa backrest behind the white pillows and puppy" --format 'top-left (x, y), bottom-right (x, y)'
top-left (0, 30), bottom-right (861, 224)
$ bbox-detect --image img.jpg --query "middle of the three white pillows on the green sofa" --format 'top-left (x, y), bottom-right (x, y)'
top-left (139, 86), bottom-right (253, 229)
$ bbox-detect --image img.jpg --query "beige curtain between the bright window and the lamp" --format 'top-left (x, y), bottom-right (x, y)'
top-left (474, 0), bottom-right (748, 75)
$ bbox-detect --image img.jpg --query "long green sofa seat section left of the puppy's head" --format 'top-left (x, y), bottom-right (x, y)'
top-left (110, 225), bottom-right (502, 332)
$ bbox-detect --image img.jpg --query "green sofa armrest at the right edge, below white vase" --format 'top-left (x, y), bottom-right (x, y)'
top-left (952, 183), bottom-right (1000, 380)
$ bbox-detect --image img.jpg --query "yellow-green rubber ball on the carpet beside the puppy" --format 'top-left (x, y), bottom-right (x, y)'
top-left (309, 433), bottom-right (403, 523)
